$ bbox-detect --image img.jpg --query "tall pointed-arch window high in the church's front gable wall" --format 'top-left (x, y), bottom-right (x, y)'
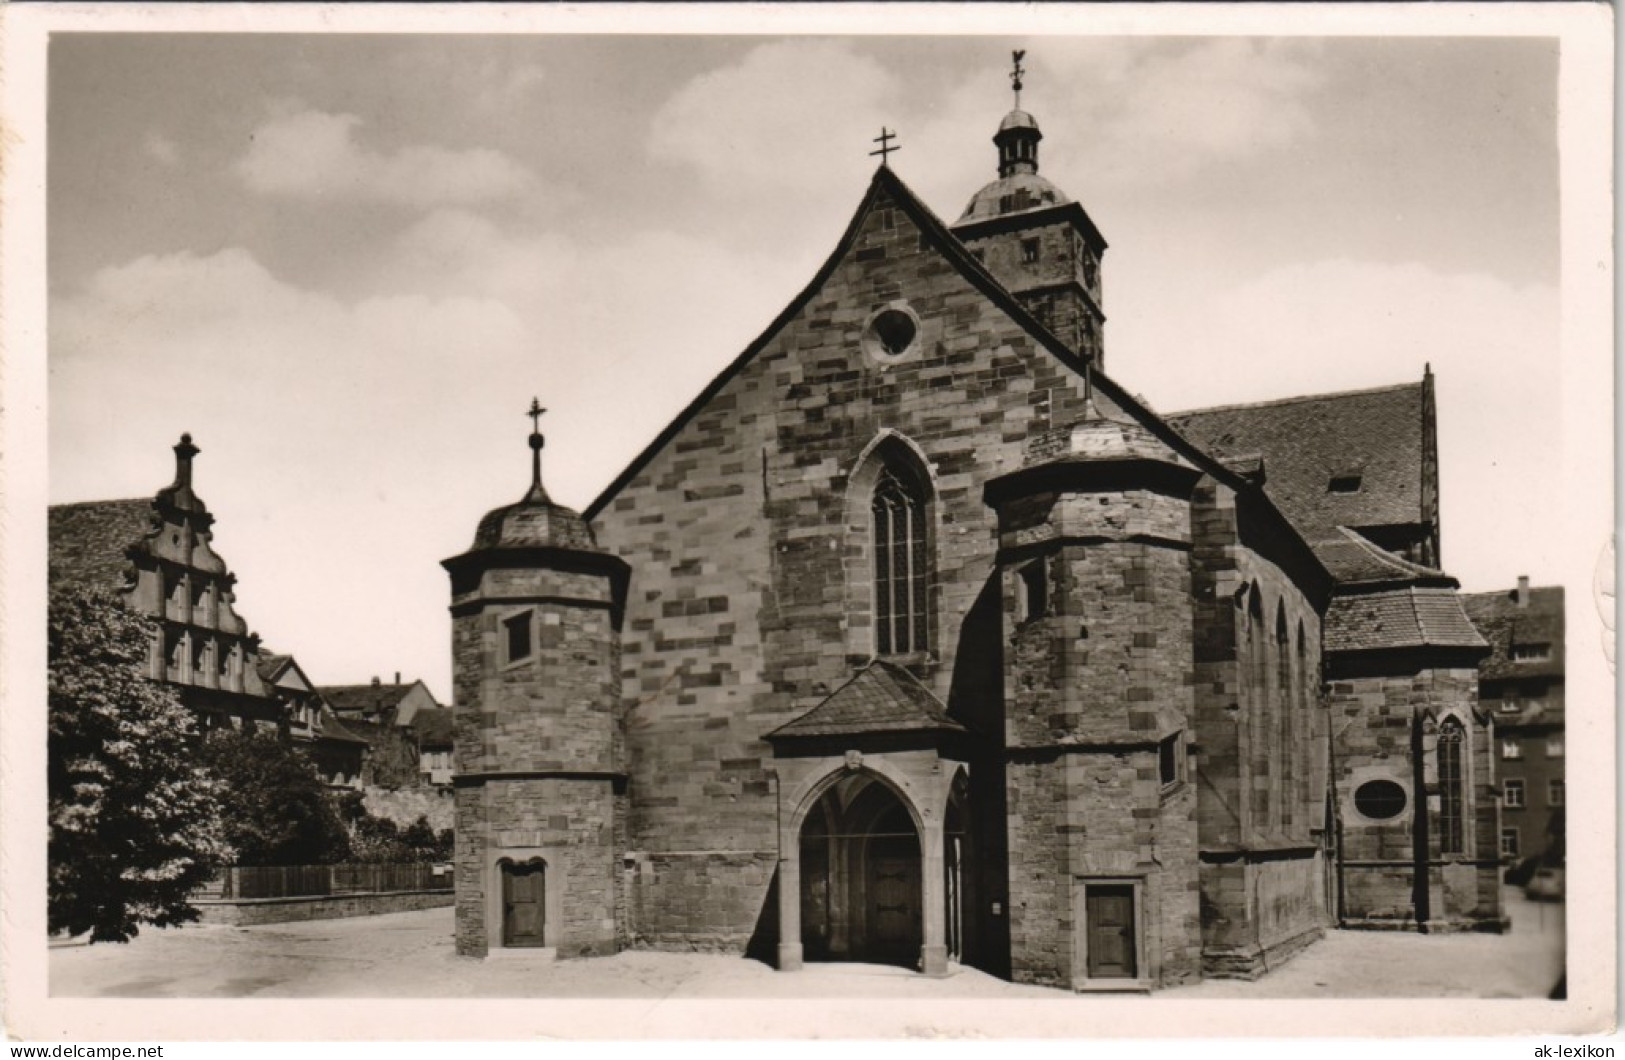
top-left (869, 462), bottom-right (931, 655)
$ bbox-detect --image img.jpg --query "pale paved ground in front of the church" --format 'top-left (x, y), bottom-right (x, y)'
top-left (50, 893), bottom-right (1563, 1000)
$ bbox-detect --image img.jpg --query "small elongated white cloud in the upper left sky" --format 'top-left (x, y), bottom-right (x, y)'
top-left (234, 109), bottom-right (535, 206)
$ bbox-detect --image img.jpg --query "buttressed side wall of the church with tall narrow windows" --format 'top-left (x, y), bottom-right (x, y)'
top-left (1191, 478), bottom-right (1329, 975)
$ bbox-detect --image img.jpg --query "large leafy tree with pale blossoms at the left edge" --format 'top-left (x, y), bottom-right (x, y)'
top-left (47, 589), bottom-right (228, 943)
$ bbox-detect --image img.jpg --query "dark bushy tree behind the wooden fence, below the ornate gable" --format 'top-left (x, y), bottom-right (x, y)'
top-left (203, 730), bottom-right (349, 865)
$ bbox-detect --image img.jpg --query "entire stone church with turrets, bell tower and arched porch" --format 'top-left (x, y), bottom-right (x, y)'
top-left (445, 78), bottom-right (1502, 990)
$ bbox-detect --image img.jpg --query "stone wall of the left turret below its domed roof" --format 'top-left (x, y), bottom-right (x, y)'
top-left (452, 567), bottom-right (624, 956)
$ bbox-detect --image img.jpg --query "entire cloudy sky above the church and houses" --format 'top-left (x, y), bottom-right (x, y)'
top-left (47, 33), bottom-right (1563, 701)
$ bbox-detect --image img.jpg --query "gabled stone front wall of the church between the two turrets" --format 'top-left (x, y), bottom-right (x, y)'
top-left (595, 178), bottom-right (1118, 940)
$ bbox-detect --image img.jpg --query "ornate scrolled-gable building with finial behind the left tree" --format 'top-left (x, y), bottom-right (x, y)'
top-left (47, 434), bottom-right (288, 728)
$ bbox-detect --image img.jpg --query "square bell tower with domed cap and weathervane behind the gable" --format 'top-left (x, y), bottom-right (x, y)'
top-left (952, 52), bottom-right (1107, 367)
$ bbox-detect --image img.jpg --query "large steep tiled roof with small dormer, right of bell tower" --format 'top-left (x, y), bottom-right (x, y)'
top-left (1167, 384), bottom-right (1424, 537)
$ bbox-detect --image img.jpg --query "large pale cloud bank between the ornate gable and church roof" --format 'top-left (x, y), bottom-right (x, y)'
top-left (49, 208), bottom-right (806, 689)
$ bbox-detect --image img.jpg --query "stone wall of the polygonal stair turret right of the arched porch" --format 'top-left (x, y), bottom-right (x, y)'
top-left (999, 491), bottom-right (1201, 987)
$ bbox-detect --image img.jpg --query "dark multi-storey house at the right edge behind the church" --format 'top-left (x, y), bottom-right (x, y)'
top-left (1466, 577), bottom-right (1567, 862)
